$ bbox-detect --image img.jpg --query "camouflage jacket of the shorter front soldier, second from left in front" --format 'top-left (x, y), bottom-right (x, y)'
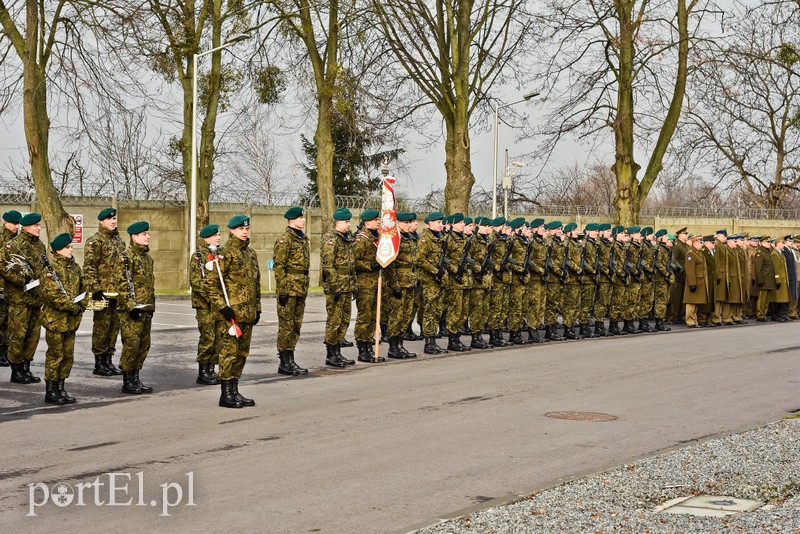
top-left (40, 254), bottom-right (89, 332)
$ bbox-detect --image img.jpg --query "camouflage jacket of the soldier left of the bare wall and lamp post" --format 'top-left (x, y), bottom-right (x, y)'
top-left (116, 242), bottom-right (156, 313)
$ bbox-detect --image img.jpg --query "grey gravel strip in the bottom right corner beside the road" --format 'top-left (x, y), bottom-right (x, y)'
top-left (419, 419), bottom-right (800, 534)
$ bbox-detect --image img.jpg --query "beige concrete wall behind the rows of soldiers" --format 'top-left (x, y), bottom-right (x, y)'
top-left (0, 202), bottom-right (800, 291)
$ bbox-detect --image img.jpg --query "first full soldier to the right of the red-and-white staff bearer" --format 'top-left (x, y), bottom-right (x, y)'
top-left (272, 206), bottom-right (311, 376)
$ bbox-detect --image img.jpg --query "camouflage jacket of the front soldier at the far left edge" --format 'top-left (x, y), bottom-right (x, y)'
top-left (0, 231), bottom-right (47, 308)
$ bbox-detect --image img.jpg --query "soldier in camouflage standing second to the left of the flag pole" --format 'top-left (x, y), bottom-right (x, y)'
top-left (320, 208), bottom-right (356, 367)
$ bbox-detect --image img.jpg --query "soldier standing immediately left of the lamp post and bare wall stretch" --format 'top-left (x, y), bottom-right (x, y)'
top-left (116, 221), bottom-right (156, 395)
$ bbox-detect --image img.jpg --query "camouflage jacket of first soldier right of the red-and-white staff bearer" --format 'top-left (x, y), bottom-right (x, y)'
top-left (274, 226), bottom-right (311, 300)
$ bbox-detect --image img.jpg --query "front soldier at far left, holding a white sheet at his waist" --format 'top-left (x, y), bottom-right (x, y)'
top-left (0, 213), bottom-right (47, 384)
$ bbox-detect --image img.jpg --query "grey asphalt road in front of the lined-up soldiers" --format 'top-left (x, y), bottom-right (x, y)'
top-left (0, 298), bottom-right (800, 533)
